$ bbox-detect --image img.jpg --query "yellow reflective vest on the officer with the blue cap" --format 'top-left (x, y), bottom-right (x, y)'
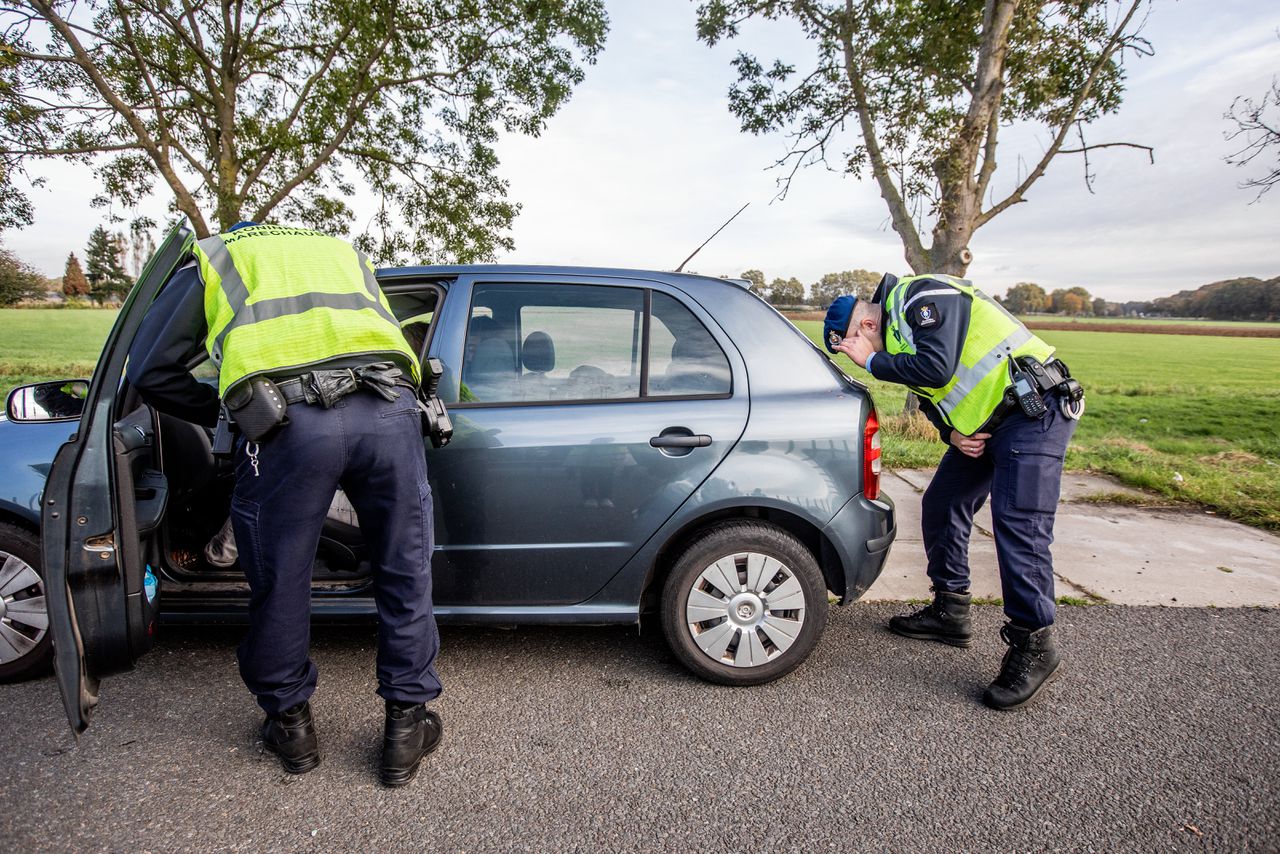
top-left (884, 275), bottom-right (1053, 435)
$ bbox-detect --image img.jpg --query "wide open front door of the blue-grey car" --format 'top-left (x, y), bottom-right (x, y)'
top-left (41, 223), bottom-right (195, 734)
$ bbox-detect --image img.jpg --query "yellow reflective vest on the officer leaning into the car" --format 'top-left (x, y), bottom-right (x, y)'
top-left (196, 225), bottom-right (420, 394)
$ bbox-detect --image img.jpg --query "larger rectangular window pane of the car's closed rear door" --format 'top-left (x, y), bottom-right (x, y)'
top-left (460, 284), bottom-right (644, 403)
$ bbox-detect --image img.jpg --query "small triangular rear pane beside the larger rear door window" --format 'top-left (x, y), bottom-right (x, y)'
top-left (649, 292), bottom-right (733, 397)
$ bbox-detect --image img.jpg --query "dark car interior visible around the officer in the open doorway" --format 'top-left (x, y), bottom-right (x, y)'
top-left (115, 286), bottom-right (440, 592)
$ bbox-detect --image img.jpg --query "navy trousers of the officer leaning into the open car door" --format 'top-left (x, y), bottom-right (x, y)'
top-left (232, 389), bottom-right (440, 714)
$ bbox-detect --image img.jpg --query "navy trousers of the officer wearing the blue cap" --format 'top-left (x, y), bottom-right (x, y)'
top-left (922, 394), bottom-right (1075, 629)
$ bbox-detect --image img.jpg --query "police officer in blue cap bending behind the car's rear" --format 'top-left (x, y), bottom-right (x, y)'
top-left (824, 274), bottom-right (1083, 709)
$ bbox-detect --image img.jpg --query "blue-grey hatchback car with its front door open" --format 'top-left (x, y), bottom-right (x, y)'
top-left (0, 228), bottom-right (895, 729)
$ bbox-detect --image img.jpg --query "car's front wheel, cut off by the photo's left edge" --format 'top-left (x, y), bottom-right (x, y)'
top-left (0, 522), bottom-right (52, 682)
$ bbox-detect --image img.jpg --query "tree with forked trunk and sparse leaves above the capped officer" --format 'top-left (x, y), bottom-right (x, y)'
top-left (698, 0), bottom-right (1151, 275)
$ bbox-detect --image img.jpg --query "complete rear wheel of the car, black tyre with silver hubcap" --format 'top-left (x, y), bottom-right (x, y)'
top-left (662, 521), bottom-right (827, 685)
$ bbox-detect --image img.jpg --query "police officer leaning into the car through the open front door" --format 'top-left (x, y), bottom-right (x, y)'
top-left (128, 223), bottom-right (442, 786)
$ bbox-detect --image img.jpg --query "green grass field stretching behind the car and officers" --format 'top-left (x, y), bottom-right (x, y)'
top-left (10, 309), bottom-right (1280, 530)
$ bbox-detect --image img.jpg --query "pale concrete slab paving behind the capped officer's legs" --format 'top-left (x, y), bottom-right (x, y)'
top-left (863, 469), bottom-right (1280, 608)
